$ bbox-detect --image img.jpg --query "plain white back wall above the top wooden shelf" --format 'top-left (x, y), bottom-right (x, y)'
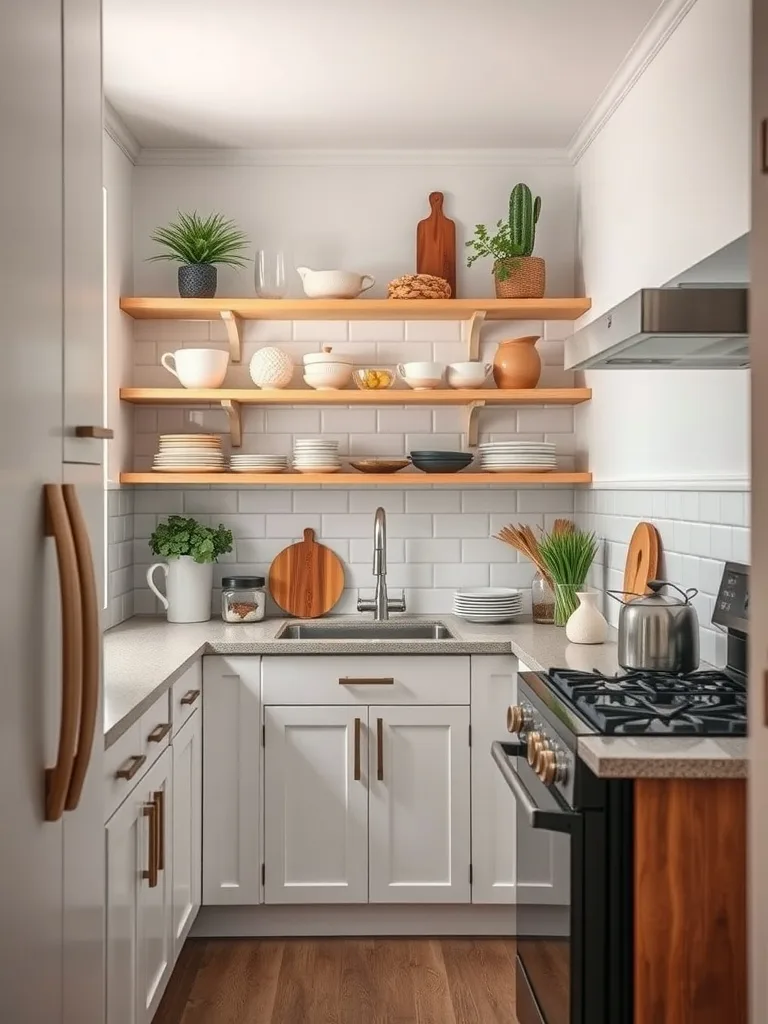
top-left (134, 156), bottom-right (575, 296)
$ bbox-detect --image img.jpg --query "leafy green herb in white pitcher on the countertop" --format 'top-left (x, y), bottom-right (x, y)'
top-left (146, 515), bottom-right (232, 623)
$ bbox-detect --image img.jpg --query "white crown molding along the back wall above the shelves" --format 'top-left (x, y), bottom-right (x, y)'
top-left (135, 143), bottom-right (571, 167)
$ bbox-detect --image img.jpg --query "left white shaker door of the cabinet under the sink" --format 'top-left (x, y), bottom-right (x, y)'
top-left (264, 706), bottom-right (368, 903)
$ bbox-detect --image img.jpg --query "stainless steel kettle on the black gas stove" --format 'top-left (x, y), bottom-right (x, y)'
top-left (608, 580), bottom-right (698, 673)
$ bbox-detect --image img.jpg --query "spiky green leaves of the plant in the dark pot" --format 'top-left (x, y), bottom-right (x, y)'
top-left (148, 210), bottom-right (250, 267)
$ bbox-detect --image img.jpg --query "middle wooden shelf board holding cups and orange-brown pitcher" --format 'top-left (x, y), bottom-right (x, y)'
top-left (120, 387), bottom-right (592, 406)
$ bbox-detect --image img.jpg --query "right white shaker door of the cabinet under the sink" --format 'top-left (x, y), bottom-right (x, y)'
top-left (369, 706), bottom-right (470, 903)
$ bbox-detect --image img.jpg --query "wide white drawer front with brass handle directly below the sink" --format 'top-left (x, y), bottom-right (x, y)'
top-left (261, 654), bottom-right (469, 705)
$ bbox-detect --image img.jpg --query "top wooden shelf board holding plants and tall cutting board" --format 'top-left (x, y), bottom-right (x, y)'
top-left (120, 298), bottom-right (592, 321)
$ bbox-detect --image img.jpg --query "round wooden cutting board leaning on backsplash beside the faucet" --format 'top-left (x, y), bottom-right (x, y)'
top-left (269, 529), bottom-right (344, 618)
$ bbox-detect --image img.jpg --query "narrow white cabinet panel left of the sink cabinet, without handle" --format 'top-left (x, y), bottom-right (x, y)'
top-left (203, 655), bottom-right (261, 906)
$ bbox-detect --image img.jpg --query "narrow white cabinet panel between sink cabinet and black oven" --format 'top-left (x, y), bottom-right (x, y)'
top-left (472, 654), bottom-right (517, 903)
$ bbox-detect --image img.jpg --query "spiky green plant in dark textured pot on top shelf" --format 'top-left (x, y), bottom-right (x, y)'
top-left (148, 210), bottom-right (250, 299)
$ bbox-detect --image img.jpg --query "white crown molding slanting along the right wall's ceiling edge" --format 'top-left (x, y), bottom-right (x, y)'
top-left (568, 0), bottom-right (696, 164)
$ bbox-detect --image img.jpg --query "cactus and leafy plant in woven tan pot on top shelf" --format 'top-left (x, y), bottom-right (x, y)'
top-left (465, 182), bottom-right (547, 299)
